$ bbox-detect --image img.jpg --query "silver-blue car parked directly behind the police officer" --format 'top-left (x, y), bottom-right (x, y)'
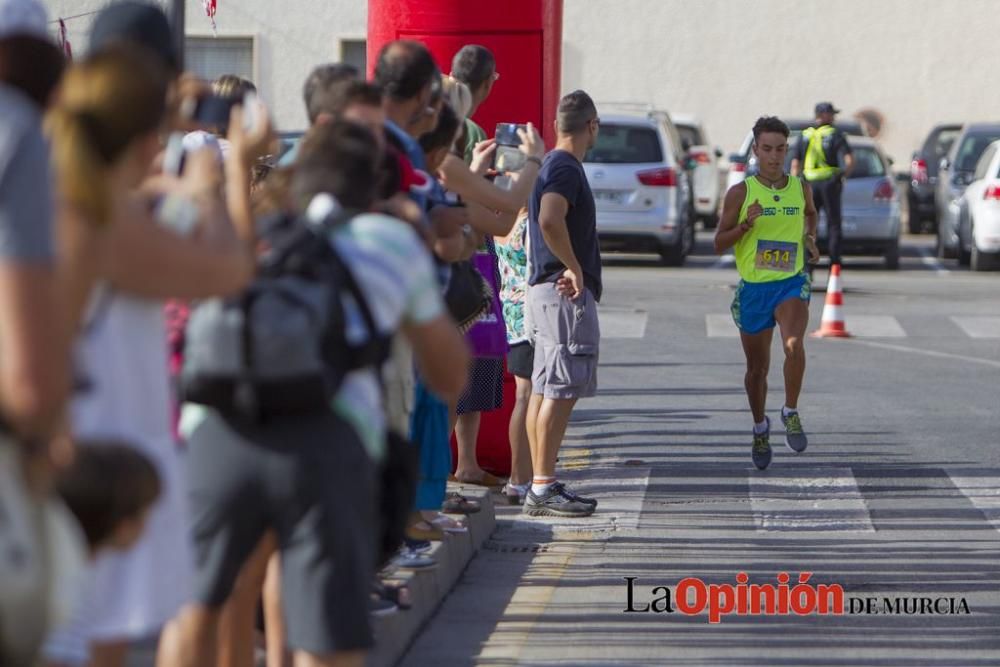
top-left (816, 135), bottom-right (900, 269)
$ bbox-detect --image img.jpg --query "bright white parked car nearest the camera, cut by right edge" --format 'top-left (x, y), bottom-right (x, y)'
top-left (958, 141), bottom-right (1000, 271)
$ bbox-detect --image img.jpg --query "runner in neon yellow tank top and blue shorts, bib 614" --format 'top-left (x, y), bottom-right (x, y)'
top-left (715, 116), bottom-right (819, 470)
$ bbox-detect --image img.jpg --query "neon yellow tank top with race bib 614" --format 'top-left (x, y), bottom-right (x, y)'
top-left (733, 176), bottom-right (806, 283)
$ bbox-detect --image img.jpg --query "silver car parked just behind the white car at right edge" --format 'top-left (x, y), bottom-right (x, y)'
top-left (934, 123), bottom-right (1000, 257)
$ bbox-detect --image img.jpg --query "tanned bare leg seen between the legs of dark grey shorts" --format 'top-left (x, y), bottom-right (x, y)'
top-left (216, 532), bottom-right (278, 667)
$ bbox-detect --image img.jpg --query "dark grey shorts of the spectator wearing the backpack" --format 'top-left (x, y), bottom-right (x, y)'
top-left (187, 411), bottom-right (378, 655)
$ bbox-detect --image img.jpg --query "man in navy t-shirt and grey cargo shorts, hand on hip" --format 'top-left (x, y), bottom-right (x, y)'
top-left (524, 90), bottom-right (602, 517)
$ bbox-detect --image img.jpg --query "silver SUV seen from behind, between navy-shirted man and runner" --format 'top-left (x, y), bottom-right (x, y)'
top-left (583, 109), bottom-right (694, 266)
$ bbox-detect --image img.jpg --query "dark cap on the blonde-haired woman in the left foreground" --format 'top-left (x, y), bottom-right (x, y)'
top-left (90, 0), bottom-right (179, 72)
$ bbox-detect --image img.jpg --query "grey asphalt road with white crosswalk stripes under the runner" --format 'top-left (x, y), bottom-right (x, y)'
top-left (403, 235), bottom-right (1000, 667)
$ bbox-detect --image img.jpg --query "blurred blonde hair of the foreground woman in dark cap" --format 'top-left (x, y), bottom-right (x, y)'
top-left (46, 46), bottom-right (167, 224)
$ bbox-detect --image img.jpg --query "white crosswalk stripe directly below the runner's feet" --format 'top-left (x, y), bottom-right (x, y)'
top-left (750, 468), bottom-right (875, 533)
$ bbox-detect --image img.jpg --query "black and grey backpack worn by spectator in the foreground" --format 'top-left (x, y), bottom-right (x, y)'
top-left (180, 195), bottom-right (391, 421)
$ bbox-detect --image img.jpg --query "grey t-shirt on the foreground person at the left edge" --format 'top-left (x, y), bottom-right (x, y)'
top-left (0, 83), bottom-right (54, 264)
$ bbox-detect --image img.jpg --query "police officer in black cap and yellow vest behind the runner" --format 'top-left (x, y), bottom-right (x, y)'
top-left (791, 102), bottom-right (854, 273)
